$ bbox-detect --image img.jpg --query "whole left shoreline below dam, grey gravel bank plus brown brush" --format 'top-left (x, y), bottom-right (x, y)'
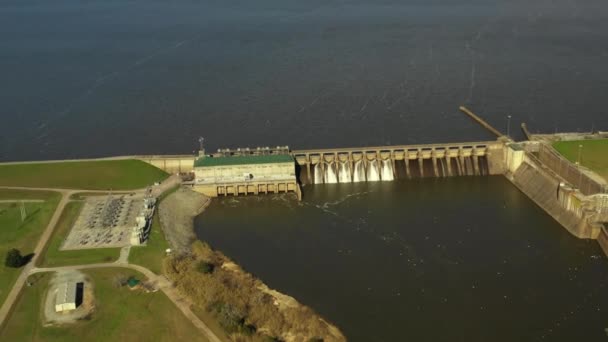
top-left (159, 187), bottom-right (346, 342)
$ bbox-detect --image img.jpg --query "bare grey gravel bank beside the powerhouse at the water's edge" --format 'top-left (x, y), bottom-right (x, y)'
top-left (158, 188), bottom-right (211, 254)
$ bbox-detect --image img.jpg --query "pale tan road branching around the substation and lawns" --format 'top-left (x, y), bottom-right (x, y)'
top-left (0, 182), bottom-right (221, 342)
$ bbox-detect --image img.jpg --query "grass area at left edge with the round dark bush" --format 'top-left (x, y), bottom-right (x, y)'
top-left (0, 190), bottom-right (61, 305)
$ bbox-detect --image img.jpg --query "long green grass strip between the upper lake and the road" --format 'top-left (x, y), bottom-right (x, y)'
top-left (0, 160), bottom-right (168, 190)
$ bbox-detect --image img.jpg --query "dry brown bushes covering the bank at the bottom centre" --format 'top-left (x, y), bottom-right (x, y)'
top-left (165, 241), bottom-right (346, 342)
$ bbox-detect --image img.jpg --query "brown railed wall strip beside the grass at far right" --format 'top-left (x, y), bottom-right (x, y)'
top-left (538, 144), bottom-right (608, 195)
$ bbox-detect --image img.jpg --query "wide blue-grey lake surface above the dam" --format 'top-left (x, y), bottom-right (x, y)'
top-left (0, 0), bottom-right (608, 160)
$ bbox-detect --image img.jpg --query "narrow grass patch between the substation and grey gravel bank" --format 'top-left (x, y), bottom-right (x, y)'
top-left (129, 185), bottom-right (179, 274)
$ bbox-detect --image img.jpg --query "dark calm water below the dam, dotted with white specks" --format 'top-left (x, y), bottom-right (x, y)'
top-left (195, 176), bottom-right (608, 341)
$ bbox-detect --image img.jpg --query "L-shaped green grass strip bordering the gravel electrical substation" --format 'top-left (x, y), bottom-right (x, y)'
top-left (38, 202), bottom-right (120, 267)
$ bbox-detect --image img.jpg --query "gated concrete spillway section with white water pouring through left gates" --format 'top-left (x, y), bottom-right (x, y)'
top-left (291, 141), bottom-right (504, 184)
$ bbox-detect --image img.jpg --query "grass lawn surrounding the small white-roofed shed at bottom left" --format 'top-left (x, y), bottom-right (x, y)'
top-left (0, 269), bottom-right (205, 342)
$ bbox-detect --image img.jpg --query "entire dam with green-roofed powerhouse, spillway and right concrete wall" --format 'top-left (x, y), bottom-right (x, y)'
top-left (131, 127), bottom-right (608, 254)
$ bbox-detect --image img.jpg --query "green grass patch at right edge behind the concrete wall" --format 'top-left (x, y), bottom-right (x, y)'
top-left (553, 139), bottom-right (608, 181)
